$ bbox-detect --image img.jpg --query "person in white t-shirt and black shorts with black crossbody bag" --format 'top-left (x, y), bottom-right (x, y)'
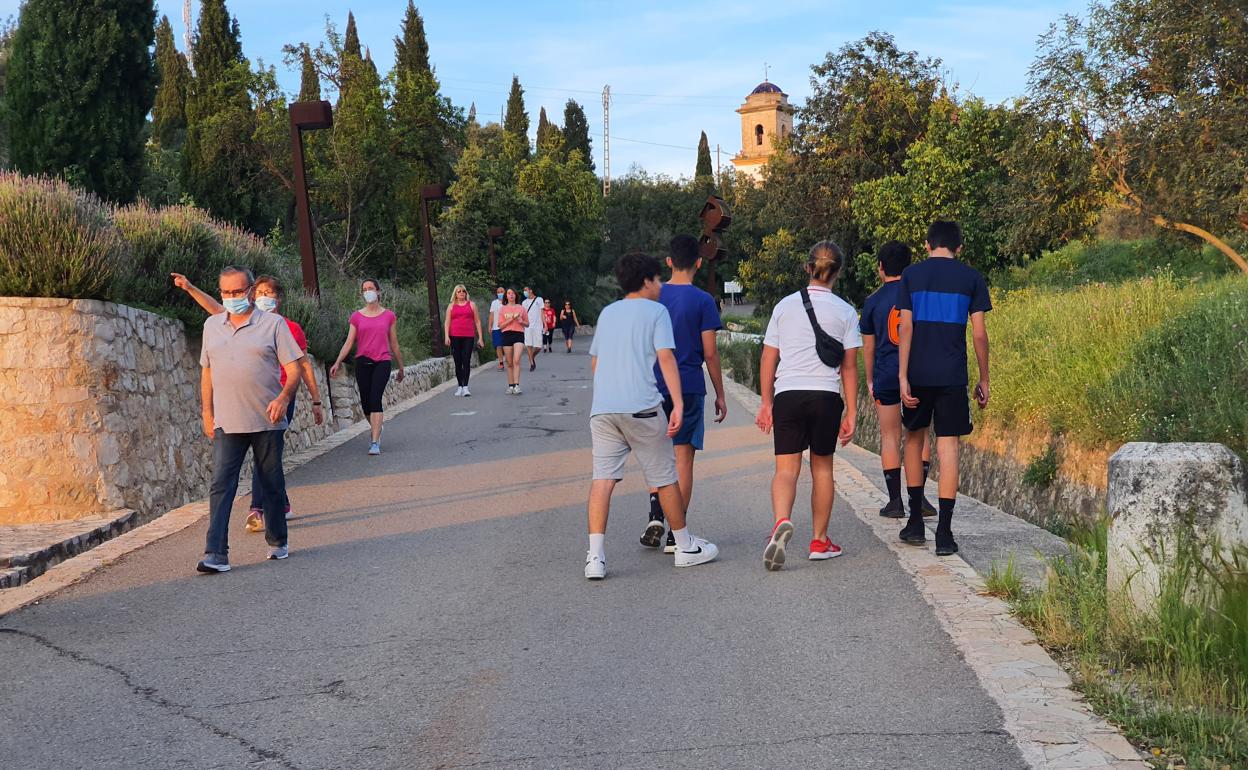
top-left (755, 241), bottom-right (862, 570)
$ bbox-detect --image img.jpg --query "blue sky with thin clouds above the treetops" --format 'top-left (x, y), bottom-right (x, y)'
top-left (0, 0), bottom-right (1086, 176)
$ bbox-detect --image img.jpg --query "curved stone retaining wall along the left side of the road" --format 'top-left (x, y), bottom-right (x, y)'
top-left (0, 297), bottom-right (454, 524)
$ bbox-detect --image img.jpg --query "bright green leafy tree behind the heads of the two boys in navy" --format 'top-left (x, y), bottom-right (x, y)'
top-left (854, 96), bottom-right (1018, 274)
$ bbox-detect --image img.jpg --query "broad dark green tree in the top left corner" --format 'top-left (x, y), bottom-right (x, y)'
top-left (4, 0), bottom-right (156, 202)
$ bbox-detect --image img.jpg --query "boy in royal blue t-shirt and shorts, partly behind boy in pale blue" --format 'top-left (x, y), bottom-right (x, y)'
top-left (641, 235), bottom-right (728, 553)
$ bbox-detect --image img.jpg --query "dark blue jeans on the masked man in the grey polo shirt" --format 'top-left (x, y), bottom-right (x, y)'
top-left (203, 428), bottom-right (286, 557)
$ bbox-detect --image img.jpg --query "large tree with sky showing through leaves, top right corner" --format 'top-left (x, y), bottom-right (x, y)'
top-left (1028, 0), bottom-right (1248, 272)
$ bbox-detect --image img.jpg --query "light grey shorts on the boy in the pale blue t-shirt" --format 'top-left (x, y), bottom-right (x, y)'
top-left (589, 406), bottom-right (676, 488)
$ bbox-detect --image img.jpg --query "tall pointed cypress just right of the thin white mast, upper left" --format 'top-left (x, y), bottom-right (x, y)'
top-left (182, 0), bottom-right (263, 232)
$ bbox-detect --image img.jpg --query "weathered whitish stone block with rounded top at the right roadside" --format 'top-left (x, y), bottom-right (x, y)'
top-left (1106, 442), bottom-right (1248, 610)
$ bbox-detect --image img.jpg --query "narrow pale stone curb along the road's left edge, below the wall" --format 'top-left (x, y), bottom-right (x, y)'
top-left (0, 362), bottom-right (494, 618)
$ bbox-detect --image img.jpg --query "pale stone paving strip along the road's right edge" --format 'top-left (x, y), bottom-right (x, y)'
top-left (724, 377), bottom-right (1149, 770)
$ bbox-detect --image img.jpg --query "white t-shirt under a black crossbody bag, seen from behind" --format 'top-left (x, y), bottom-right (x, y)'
top-left (763, 286), bottom-right (862, 393)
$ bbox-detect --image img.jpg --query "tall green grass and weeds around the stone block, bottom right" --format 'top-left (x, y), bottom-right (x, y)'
top-left (986, 522), bottom-right (1248, 770)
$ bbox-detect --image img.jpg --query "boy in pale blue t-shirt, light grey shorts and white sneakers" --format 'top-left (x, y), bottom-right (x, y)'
top-left (585, 252), bottom-right (719, 580)
